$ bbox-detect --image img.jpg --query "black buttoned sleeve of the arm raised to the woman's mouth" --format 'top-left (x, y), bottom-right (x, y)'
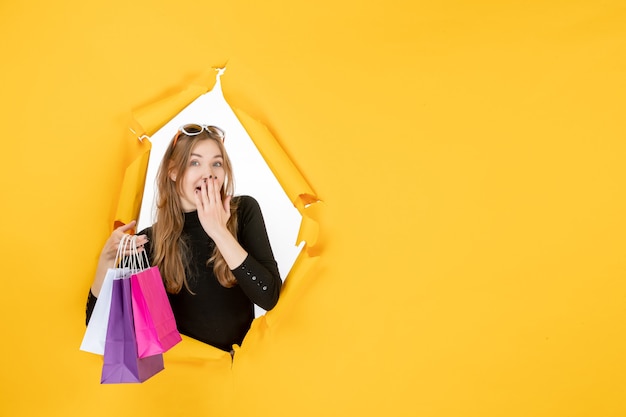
top-left (232, 196), bottom-right (282, 310)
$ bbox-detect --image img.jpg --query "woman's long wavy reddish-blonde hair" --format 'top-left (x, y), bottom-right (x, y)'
top-left (152, 129), bottom-right (237, 294)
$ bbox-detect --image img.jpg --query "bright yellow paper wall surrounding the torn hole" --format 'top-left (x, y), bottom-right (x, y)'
top-left (0, 0), bottom-right (626, 417)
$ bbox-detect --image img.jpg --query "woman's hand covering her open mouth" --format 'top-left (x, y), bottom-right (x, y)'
top-left (194, 176), bottom-right (231, 240)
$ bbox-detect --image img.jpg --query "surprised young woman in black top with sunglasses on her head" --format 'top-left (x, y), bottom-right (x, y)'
top-left (87, 124), bottom-right (282, 351)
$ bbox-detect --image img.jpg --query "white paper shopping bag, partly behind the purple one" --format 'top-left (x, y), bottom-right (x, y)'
top-left (80, 236), bottom-right (133, 355)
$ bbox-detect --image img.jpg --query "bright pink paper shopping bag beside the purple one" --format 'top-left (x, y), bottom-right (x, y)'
top-left (131, 266), bottom-right (182, 358)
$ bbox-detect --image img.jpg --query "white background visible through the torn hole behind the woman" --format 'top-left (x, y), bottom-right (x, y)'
top-left (137, 72), bottom-right (303, 316)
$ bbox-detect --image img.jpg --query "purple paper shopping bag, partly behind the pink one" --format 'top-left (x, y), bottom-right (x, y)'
top-left (100, 279), bottom-right (164, 384)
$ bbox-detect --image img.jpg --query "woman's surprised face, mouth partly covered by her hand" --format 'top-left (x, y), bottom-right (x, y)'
top-left (173, 139), bottom-right (225, 212)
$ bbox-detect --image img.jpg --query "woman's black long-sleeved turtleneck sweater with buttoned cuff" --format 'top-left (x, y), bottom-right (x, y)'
top-left (87, 196), bottom-right (282, 351)
